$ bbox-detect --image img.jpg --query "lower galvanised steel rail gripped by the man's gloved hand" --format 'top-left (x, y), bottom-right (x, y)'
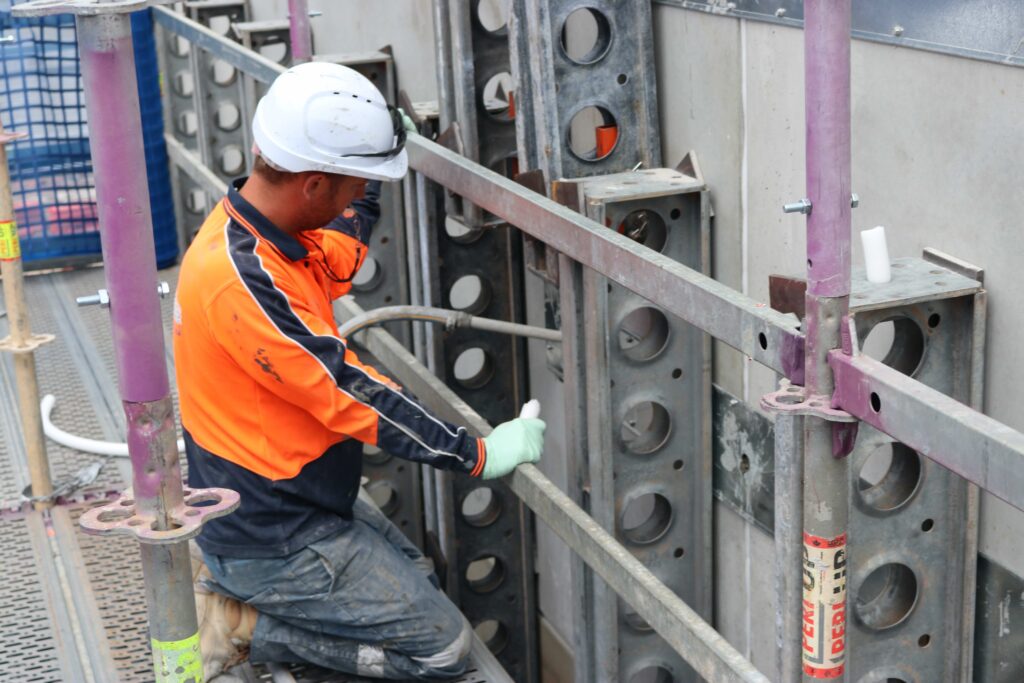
top-left (336, 297), bottom-right (768, 683)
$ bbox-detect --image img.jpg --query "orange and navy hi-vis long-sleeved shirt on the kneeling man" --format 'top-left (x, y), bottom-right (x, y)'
top-left (174, 180), bottom-right (485, 557)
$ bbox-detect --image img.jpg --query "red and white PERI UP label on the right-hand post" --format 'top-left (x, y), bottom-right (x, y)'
top-left (803, 533), bottom-right (846, 680)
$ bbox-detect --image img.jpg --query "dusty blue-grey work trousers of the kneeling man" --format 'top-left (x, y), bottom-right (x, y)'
top-left (204, 500), bottom-right (472, 679)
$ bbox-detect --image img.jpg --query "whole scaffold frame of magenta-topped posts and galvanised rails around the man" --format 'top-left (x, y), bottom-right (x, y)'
top-left (9, 0), bottom-right (1024, 682)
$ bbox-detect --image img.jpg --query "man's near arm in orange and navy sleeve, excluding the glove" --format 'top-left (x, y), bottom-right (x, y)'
top-left (206, 266), bottom-right (486, 476)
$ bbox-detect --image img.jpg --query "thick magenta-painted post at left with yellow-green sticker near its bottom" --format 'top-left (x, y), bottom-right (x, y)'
top-left (76, 13), bottom-right (203, 683)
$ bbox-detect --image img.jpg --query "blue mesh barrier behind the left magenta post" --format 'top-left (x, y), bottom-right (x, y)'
top-left (0, 2), bottom-right (178, 267)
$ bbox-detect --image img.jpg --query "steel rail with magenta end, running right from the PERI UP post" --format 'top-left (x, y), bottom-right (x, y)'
top-left (828, 351), bottom-right (1024, 510)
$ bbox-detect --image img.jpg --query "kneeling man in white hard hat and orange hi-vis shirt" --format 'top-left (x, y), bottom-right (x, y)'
top-left (174, 62), bottom-right (545, 679)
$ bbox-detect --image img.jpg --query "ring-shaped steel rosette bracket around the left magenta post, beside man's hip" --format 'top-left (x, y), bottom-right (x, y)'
top-left (79, 487), bottom-right (241, 545)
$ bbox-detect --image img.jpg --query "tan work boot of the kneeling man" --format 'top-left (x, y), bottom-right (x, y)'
top-left (188, 542), bottom-right (257, 680)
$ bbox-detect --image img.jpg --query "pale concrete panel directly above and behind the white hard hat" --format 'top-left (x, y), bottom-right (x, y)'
top-left (250, 0), bottom-right (437, 101)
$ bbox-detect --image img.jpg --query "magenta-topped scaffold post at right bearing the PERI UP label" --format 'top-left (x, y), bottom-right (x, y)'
top-left (783, 0), bottom-right (852, 683)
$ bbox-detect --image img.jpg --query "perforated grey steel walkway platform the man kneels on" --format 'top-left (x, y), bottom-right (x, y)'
top-left (0, 268), bottom-right (511, 683)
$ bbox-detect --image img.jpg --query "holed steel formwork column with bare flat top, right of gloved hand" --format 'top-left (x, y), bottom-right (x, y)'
top-left (556, 169), bottom-right (713, 681)
